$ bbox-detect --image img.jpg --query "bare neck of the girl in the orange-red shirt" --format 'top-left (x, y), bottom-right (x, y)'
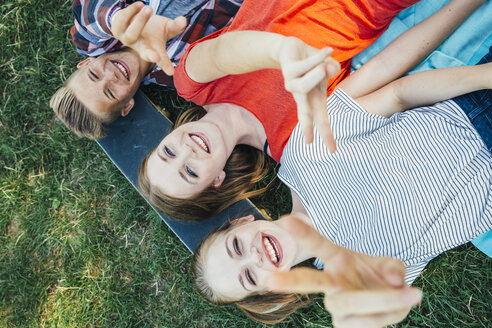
top-left (202, 103), bottom-right (266, 152)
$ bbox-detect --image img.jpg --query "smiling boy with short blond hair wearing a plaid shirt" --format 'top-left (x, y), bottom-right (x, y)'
top-left (50, 0), bottom-right (241, 139)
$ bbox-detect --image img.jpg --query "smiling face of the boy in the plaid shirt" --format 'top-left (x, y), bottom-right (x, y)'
top-left (67, 49), bottom-right (149, 122)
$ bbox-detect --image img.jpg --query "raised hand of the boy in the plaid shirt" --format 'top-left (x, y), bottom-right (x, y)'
top-left (111, 2), bottom-right (186, 75)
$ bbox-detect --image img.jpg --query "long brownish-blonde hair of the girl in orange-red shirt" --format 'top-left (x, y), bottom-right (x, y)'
top-left (138, 107), bottom-right (269, 221)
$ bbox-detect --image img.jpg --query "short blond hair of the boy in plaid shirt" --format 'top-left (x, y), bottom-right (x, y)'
top-left (50, 72), bottom-right (120, 139)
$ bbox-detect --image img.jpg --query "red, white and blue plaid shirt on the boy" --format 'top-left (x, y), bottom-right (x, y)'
top-left (70, 0), bottom-right (243, 86)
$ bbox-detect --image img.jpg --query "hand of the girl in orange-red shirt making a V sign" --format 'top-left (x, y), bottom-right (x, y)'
top-left (278, 38), bottom-right (340, 153)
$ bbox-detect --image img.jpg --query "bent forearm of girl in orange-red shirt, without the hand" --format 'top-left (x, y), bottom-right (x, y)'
top-left (186, 31), bottom-right (286, 83)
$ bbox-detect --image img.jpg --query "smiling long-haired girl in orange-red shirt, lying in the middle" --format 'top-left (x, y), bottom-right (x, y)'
top-left (139, 0), bottom-right (432, 220)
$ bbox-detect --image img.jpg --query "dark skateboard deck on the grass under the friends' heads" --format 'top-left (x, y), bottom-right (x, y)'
top-left (97, 91), bottom-right (264, 252)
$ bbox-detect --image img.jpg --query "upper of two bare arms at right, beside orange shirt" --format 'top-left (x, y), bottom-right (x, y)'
top-left (339, 0), bottom-right (485, 98)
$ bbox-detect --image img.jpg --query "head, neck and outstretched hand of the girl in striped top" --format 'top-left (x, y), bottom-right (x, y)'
top-left (193, 211), bottom-right (422, 328)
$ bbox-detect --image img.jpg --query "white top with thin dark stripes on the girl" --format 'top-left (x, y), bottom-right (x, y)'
top-left (278, 89), bottom-right (492, 284)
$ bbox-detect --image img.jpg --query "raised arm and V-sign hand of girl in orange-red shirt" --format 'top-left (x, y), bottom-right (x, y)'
top-left (185, 31), bottom-right (340, 152)
